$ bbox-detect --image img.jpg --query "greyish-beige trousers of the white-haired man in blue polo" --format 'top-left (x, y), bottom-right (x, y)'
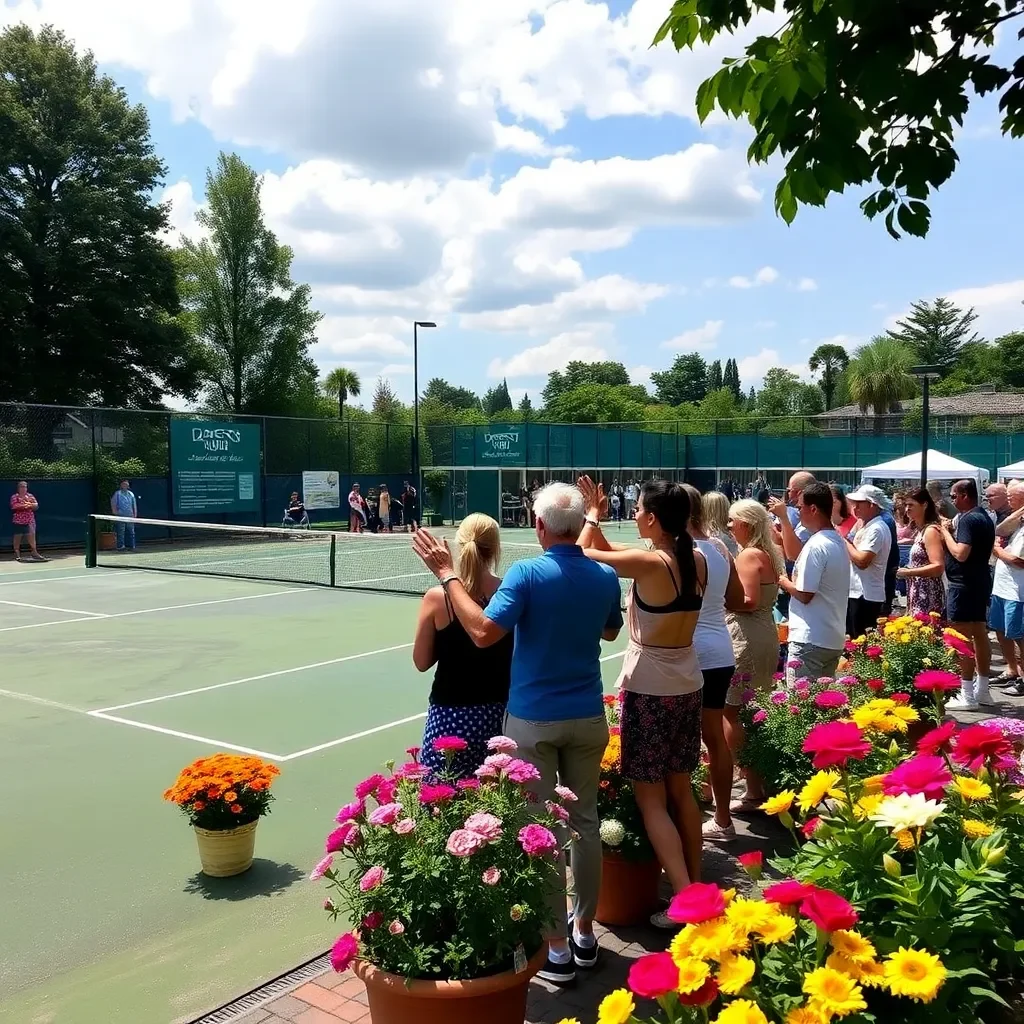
top-left (505, 715), bottom-right (608, 940)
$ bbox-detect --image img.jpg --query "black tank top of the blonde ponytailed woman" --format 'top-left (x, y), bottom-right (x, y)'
top-left (430, 594), bottom-right (514, 708)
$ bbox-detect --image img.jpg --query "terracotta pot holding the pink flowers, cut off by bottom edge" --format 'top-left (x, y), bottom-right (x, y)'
top-left (352, 943), bottom-right (548, 1024)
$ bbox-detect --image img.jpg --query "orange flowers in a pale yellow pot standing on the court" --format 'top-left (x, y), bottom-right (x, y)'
top-left (164, 754), bottom-right (281, 879)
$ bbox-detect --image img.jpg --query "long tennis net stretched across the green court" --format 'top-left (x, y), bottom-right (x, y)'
top-left (86, 515), bottom-right (561, 594)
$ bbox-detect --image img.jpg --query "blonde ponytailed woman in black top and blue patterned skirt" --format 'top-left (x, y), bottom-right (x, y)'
top-left (413, 512), bottom-right (513, 777)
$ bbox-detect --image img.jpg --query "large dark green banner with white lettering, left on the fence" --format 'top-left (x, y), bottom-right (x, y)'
top-left (171, 420), bottom-right (260, 515)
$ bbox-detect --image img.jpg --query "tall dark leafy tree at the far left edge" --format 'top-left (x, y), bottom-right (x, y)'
top-left (0, 25), bottom-right (199, 407)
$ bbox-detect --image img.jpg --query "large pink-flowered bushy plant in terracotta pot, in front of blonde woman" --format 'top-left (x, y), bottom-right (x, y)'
top-left (311, 736), bottom-right (575, 1024)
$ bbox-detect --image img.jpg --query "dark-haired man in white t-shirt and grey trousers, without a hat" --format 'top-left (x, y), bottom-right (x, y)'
top-left (778, 483), bottom-right (851, 682)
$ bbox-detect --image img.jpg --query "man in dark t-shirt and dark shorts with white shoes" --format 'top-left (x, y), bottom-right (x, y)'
top-left (942, 479), bottom-right (995, 711)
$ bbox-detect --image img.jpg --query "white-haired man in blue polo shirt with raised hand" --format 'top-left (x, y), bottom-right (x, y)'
top-left (413, 483), bottom-right (623, 985)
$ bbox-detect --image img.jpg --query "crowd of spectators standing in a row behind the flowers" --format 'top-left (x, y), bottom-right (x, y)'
top-left (403, 472), bottom-right (1011, 984)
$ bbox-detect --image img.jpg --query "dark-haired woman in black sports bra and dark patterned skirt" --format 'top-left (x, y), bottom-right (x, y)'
top-left (580, 477), bottom-right (708, 928)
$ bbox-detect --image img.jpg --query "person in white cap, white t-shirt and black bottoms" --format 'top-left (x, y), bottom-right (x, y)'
top-left (846, 483), bottom-right (892, 637)
